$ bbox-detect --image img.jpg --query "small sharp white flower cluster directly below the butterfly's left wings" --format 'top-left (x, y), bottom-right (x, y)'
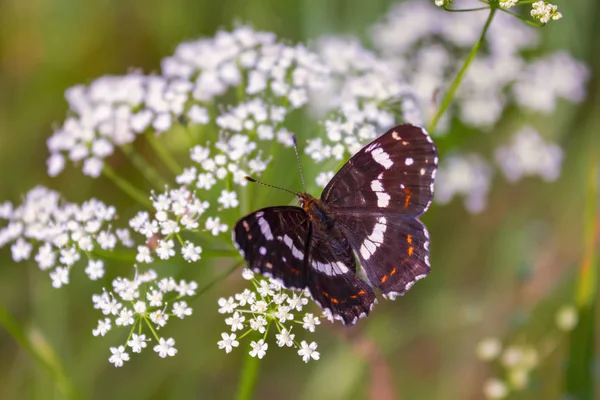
top-left (217, 269), bottom-right (321, 362)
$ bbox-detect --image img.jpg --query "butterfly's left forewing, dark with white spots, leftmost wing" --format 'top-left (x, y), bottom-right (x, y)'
top-left (233, 206), bottom-right (310, 289)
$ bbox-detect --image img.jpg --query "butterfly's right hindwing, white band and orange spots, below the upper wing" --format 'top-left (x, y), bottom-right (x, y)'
top-left (338, 215), bottom-right (431, 299)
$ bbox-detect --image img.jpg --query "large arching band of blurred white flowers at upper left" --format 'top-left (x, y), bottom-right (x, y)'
top-left (48, 26), bottom-right (328, 177)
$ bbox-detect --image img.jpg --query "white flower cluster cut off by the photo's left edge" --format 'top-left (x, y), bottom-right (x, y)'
top-left (0, 186), bottom-right (133, 288)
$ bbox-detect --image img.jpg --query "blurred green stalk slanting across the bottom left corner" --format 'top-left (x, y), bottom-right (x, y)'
top-left (0, 305), bottom-right (81, 399)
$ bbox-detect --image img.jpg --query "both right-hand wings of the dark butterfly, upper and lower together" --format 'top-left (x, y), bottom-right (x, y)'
top-left (321, 125), bottom-right (438, 299)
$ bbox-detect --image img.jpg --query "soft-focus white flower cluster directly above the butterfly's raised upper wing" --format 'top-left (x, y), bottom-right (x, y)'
top-left (305, 37), bottom-right (414, 162)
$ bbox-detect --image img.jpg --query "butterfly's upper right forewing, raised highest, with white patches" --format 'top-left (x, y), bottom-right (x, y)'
top-left (321, 124), bottom-right (438, 217)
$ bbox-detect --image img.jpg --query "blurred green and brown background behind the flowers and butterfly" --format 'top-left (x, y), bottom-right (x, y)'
top-left (0, 0), bottom-right (600, 399)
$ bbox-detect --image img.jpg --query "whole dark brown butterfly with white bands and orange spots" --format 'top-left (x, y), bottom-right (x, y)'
top-left (233, 124), bottom-right (438, 325)
